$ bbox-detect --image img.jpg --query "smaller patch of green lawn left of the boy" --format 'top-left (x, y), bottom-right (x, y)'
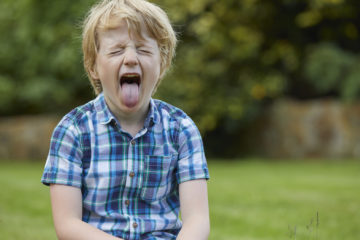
top-left (0, 162), bottom-right (56, 240)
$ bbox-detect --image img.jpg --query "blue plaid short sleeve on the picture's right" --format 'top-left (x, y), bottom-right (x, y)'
top-left (176, 118), bottom-right (210, 184)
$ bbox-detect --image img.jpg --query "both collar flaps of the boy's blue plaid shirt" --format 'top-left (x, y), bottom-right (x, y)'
top-left (94, 93), bottom-right (160, 128)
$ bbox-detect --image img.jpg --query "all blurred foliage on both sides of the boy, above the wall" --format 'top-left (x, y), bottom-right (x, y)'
top-left (0, 0), bottom-right (360, 133)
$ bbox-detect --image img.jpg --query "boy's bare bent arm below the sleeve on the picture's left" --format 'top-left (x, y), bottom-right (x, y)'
top-left (50, 184), bottom-right (124, 240)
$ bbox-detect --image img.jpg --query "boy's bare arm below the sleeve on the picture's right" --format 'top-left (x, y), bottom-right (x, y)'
top-left (177, 179), bottom-right (210, 240)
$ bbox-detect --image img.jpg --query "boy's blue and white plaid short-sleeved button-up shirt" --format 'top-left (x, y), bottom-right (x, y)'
top-left (41, 94), bottom-right (209, 240)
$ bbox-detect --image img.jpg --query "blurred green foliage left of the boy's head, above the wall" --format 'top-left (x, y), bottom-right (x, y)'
top-left (0, 0), bottom-right (96, 114)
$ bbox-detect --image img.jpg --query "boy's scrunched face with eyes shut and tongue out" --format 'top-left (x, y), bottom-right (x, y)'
top-left (93, 21), bottom-right (160, 116)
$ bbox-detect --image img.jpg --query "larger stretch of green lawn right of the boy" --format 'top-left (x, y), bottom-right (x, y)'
top-left (209, 161), bottom-right (360, 240)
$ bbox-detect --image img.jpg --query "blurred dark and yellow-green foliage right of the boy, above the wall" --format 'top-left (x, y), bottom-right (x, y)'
top-left (156, 0), bottom-right (360, 133)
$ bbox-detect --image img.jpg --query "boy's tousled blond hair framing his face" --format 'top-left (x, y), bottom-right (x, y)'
top-left (82, 0), bottom-right (177, 94)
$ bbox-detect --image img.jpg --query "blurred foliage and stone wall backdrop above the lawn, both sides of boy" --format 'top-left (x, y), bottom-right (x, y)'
top-left (0, 0), bottom-right (360, 159)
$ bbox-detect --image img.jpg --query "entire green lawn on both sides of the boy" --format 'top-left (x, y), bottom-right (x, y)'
top-left (0, 161), bottom-right (360, 240)
